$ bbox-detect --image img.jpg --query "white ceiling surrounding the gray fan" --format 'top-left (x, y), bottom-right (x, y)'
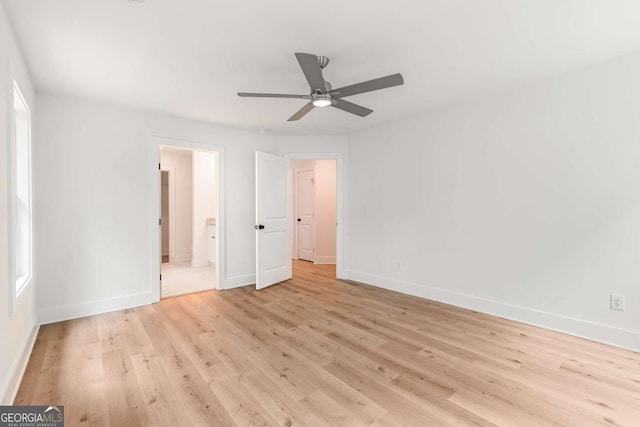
top-left (4, 0), bottom-right (640, 135)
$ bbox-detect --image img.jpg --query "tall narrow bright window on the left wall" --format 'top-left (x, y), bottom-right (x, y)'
top-left (11, 81), bottom-right (32, 297)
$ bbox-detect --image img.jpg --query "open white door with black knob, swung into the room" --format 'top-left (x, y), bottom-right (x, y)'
top-left (256, 151), bottom-right (292, 289)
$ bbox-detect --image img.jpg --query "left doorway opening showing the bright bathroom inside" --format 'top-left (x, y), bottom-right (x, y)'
top-left (159, 145), bottom-right (218, 298)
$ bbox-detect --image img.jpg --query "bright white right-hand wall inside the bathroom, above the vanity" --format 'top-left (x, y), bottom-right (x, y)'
top-left (191, 150), bottom-right (217, 267)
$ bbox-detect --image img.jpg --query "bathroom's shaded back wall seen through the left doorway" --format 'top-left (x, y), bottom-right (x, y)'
top-left (160, 147), bottom-right (193, 262)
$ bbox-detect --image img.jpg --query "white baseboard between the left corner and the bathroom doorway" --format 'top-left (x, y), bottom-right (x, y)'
top-left (40, 292), bottom-right (153, 325)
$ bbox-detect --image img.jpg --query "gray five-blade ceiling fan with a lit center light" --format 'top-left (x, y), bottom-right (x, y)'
top-left (238, 53), bottom-right (404, 122)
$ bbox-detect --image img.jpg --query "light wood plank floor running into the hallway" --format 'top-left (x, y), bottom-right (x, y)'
top-left (15, 262), bottom-right (640, 427)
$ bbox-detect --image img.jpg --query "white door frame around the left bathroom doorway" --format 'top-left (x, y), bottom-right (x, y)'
top-left (147, 136), bottom-right (227, 303)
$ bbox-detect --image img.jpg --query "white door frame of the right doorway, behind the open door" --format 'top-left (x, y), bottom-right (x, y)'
top-left (283, 152), bottom-right (348, 279)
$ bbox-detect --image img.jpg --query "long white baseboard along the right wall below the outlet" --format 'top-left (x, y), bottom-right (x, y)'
top-left (346, 270), bottom-right (640, 351)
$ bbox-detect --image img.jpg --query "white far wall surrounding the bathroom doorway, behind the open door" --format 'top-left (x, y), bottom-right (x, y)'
top-left (33, 95), bottom-right (347, 322)
